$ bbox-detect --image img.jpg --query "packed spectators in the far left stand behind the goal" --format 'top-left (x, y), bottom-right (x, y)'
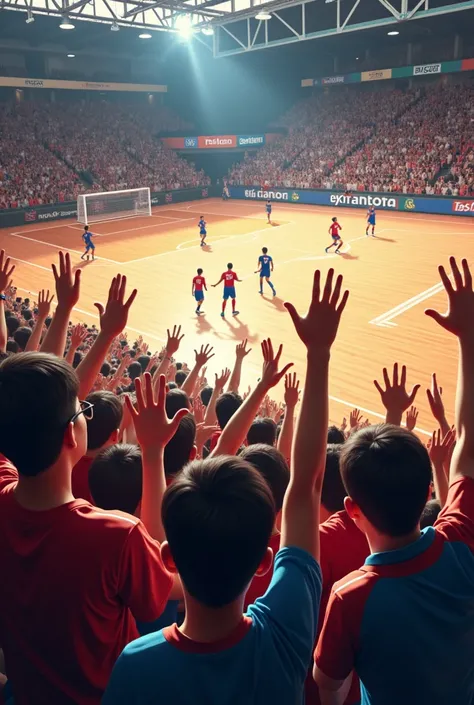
top-left (0, 101), bottom-right (209, 208)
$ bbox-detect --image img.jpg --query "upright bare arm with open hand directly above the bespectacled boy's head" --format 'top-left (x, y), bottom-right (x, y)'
top-left (40, 252), bottom-right (81, 357)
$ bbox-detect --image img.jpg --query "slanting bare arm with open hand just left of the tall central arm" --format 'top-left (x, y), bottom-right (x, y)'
top-left (211, 338), bottom-right (293, 456)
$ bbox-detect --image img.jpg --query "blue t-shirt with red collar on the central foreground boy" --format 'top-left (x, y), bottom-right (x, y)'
top-left (103, 547), bottom-right (321, 705)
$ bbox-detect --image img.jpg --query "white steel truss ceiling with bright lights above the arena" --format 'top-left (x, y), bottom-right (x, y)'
top-left (0, 0), bottom-right (474, 58)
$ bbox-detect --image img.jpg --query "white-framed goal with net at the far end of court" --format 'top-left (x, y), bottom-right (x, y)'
top-left (77, 188), bottom-right (151, 225)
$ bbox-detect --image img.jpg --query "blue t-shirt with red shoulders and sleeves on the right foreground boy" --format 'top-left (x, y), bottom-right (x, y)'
top-left (315, 477), bottom-right (474, 705)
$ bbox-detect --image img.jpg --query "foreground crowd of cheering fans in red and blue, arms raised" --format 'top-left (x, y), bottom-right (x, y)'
top-left (0, 241), bottom-right (474, 705)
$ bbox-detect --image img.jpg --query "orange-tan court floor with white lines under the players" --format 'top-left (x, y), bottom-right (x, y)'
top-left (0, 199), bottom-right (474, 433)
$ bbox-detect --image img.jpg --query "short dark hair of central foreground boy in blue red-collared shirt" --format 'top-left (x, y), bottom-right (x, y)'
top-left (162, 456), bottom-right (275, 608)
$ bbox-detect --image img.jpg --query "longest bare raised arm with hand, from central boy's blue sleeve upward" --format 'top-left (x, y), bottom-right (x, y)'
top-left (280, 269), bottom-right (349, 559)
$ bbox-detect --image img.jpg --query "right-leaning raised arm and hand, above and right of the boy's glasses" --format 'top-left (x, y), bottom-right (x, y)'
top-left (77, 274), bottom-right (137, 399)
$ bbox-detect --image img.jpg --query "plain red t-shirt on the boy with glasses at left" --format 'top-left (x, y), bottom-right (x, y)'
top-left (0, 456), bottom-right (172, 705)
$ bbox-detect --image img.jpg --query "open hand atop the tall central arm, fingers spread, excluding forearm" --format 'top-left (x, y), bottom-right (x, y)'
top-left (285, 269), bottom-right (349, 351)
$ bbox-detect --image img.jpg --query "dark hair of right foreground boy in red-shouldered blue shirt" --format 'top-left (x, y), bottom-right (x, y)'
top-left (340, 424), bottom-right (431, 537)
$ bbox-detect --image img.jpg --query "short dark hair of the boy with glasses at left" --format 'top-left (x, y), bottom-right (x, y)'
top-left (0, 352), bottom-right (79, 477)
